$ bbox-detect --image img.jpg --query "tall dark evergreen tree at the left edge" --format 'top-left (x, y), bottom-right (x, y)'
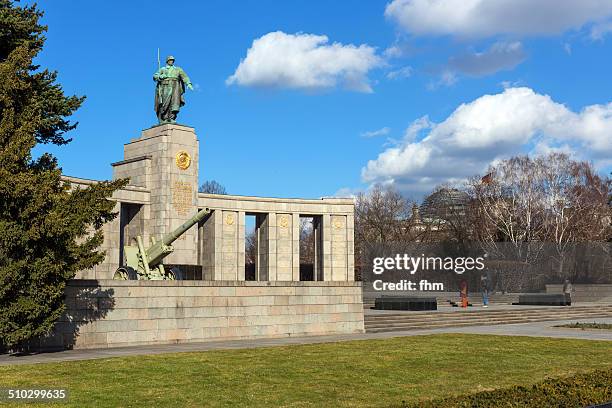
top-left (0, 0), bottom-right (126, 349)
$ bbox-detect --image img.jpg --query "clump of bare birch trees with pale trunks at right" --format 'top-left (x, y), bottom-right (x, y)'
top-left (468, 153), bottom-right (610, 290)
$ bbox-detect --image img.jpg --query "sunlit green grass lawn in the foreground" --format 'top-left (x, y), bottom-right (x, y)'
top-left (0, 334), bottom-right (612, 408)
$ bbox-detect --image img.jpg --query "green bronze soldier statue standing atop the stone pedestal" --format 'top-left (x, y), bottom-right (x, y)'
top-left (153, 55), bottom-right (193, 124)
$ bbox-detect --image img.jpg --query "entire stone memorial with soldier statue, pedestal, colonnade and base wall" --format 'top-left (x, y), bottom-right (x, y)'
top-left (47, 57), bottom-right (364, 348)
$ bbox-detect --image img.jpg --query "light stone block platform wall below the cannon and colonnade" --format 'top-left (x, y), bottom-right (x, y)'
top-left (42, 280), bottom-right (364, 350)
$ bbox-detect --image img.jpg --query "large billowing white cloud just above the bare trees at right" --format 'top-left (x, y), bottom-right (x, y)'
top-left (361, 87), bottom-right (612, 192)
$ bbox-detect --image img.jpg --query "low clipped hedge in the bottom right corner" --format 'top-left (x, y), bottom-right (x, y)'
top-left (400, 369), bottom-right (612, 408)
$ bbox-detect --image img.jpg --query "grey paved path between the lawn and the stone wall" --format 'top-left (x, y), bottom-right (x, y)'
top-left (0, 318), bottom-right (612, 365)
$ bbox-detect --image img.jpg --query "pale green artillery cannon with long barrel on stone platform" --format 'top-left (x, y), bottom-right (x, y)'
top-left (113, 208), bottom-right (210, 280)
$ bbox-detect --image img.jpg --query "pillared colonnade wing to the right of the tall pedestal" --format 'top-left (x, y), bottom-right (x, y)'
top-left (199, 194), bottom-right (355, 281)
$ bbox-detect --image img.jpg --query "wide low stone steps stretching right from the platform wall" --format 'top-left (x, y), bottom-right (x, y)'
top-left (365, 305), bottom-right (612, 333)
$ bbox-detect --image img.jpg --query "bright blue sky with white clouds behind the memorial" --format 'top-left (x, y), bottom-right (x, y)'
top-left (32, 0), bottom-right (612, 198)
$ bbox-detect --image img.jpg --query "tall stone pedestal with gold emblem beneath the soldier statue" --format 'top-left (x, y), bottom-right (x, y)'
top-left (113, 124), bottom-right (199, 265)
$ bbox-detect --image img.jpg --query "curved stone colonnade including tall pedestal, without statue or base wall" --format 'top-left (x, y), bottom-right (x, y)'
top-left (65, 125), bottom-right (354, 281)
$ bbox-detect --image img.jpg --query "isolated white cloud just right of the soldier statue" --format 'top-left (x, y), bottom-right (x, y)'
top-left (226, 31), bottom-right (384, 92)
